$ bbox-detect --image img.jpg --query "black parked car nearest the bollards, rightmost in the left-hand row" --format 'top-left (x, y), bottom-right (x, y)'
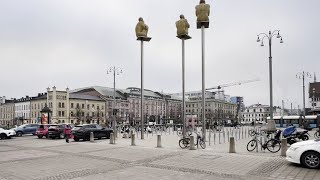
top-left (72, 124), bottom-right (113, 141)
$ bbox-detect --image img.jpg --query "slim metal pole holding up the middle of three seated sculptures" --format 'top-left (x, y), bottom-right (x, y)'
top-left (182, 39), bottom-right (186, 138)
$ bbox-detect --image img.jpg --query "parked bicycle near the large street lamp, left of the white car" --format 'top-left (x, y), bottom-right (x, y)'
top-left (247, 130), bottom-right (281, 153)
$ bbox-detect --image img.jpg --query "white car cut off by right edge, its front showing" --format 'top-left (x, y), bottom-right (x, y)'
top-left (286, 139), bottom-right (320, 169)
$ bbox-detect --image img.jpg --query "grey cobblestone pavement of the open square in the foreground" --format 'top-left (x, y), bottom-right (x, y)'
top-left (0, 127), bottom-right (320, 180)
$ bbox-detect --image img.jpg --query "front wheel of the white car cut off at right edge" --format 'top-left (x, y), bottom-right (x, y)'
top-left (301, 151), bottom-right (320, 169)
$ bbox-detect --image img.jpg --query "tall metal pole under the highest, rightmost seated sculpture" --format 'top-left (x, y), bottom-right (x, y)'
top-left (201, 26), bottom-right (206, 141)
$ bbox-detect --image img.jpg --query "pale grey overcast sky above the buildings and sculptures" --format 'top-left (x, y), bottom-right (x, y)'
top-left (0, 0), bottom-right (320, 107)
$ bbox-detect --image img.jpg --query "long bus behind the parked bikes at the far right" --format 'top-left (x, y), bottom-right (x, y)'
top-left (267, 115), bottom-right (320, 128)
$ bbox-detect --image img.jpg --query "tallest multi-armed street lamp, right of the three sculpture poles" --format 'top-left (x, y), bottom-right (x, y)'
top-left (257, 30), bottom-right (283, 124)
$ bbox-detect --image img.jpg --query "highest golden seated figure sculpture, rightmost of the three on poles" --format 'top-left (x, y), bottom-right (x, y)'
top-left (196, 0), bottom-right (210, 29)
